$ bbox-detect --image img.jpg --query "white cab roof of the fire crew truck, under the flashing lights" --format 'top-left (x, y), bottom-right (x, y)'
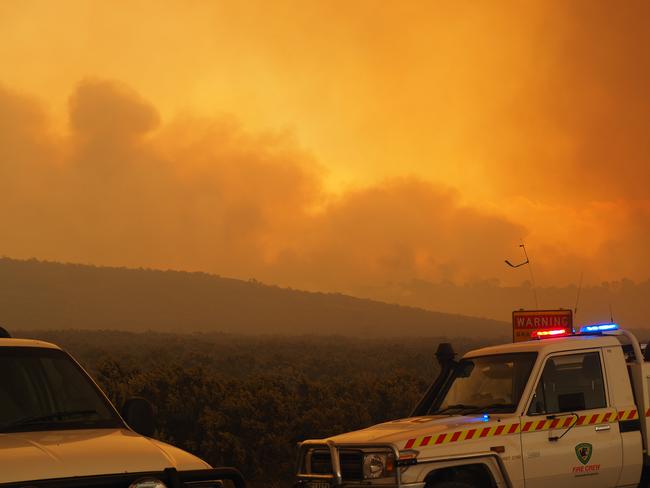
top-left (465, 334), bottom-right (621, 357)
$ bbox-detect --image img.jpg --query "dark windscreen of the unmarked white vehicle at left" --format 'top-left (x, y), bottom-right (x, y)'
top-left (0, 347), bottom-right (123, 432)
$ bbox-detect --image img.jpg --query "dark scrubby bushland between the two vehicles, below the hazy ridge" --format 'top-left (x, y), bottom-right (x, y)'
top-left (18, 330), bottom-right (502, 488)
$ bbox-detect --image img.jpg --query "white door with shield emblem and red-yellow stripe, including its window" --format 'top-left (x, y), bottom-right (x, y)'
top-left (521, 349), bottom-right (623, 488)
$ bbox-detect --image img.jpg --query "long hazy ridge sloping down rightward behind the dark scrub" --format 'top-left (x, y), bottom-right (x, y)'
top-left (0, 258), bottom-right (510, 337)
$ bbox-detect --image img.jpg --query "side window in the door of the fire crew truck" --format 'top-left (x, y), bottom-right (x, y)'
top-left (528, 352), bottom-right (607, 415)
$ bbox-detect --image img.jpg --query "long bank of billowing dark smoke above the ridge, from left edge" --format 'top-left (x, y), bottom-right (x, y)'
top-left (0, 80), bottom-right (524, 289)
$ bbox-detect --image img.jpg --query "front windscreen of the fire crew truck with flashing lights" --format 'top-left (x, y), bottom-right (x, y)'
top-left (435, 352), bottom-right (537, 415)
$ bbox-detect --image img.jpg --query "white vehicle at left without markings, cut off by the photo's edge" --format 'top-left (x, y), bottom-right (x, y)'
top-left (0, 327), bottom-right (245, 488)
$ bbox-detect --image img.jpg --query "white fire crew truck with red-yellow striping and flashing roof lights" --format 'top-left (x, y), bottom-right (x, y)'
top-left (297, 324), bottom-right (650, 488)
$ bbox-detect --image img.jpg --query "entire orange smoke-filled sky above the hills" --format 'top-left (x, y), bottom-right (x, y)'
top-left (0, 0), bottom-right (650, 299)
